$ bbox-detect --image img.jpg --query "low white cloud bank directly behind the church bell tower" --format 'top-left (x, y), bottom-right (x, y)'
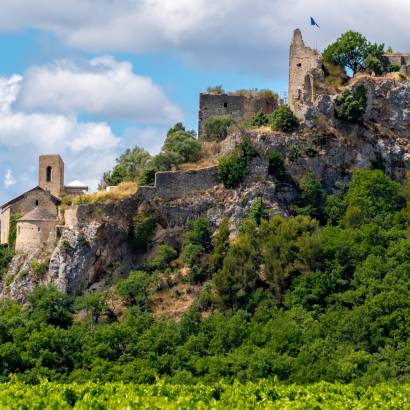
top-left (0, 69), bottom-right (170, 202)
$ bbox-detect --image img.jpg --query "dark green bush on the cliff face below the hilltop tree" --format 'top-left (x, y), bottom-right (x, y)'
top-left (336, 85), bottom-right (367, 123)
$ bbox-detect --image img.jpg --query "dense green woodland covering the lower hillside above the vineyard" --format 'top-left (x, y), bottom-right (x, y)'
top-left (0, 170), bottom-right (410, 388)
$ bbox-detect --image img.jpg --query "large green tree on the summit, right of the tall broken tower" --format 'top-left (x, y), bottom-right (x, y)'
top-left (323, 31), bottom-right (384, 75)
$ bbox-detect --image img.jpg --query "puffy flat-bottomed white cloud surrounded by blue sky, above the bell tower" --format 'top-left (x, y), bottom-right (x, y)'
top-left (16, 56), bottom-right (183, 124)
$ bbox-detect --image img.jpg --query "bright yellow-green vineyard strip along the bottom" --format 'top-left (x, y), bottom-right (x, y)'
top-left (0, 381), bottom-right (410, 410)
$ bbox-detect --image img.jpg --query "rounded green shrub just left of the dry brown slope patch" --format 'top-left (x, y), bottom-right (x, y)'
top-left (116, 271), bottom-right (150, 309)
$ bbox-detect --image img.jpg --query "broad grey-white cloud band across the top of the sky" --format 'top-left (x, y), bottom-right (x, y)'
top-left (0, 0), bottom-right (410, 75)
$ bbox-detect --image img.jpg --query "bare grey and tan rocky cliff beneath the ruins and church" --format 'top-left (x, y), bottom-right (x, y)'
top-left (0, 77), bottom-right (410, 301)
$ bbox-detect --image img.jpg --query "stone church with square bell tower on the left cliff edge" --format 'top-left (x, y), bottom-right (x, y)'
top-left (0, 155), bottom-right (88, 252)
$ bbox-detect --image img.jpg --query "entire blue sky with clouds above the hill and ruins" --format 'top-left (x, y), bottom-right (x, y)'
top-left (0, 0), bottom-right (410, 203)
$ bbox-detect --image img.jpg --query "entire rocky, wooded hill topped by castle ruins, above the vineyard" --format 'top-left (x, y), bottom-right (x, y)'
top-left (0, 30), bottom-right (410, 384)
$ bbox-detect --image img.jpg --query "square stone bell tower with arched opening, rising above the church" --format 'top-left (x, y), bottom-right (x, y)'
top-left (38, 155), bottom-right (64, 197)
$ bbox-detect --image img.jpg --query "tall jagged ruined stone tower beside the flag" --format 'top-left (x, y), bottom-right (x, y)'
top-left (288, 29), bottom-right (321, 119)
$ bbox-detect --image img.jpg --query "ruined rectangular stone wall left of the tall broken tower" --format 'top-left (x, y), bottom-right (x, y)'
top-left (198, 94), bottom-right (277, 139)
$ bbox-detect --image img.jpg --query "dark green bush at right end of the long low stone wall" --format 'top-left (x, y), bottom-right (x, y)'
top-left (217, 139), bottom-right (256, 189)
